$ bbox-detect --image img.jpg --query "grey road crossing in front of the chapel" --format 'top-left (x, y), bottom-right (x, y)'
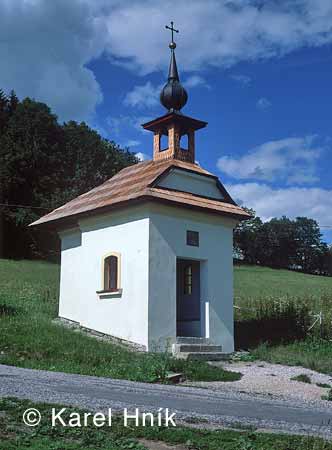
top-left (0, 365), bottom-right (332, 438)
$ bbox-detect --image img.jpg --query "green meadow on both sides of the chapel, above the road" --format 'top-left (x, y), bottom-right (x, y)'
top-left (0, 260), bottom-right (332, 381)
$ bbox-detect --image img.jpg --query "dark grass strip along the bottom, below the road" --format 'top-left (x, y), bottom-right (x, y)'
top-left (0, 399), bottom-right (332, 450)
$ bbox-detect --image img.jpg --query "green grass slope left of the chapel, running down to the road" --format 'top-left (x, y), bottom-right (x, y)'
top-left (0, 260), bottom-right (240, 382)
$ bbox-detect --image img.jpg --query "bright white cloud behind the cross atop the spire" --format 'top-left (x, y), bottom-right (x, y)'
top-left (106, 0), bottom-right (332, 74)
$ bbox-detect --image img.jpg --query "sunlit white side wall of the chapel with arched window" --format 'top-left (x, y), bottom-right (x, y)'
top-left (59, 207), bottom-right (149, 346)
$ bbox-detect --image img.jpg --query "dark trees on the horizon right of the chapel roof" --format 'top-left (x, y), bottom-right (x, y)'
top-left (234, 208), bottom-right (332, 275)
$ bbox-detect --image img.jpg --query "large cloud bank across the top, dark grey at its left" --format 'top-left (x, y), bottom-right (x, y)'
top-left (0, 0), bottom-right (332, 120)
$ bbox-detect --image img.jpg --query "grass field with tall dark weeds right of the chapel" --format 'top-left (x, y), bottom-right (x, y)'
top-left (234, 266), bottom-right (332, 375)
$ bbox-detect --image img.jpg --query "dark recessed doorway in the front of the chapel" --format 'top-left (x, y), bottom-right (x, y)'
top-left (176, 259), bottom-right (201, 337)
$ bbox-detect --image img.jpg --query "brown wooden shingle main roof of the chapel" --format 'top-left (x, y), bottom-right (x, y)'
top-left (31, 159), bottom-right (250, 228)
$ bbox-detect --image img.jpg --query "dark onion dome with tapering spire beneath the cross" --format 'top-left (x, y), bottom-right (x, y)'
top-left (160, 33), bottom-right (188, 112)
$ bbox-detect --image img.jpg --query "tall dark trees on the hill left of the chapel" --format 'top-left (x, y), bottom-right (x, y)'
top-left (0, 90), bottom-right (137, 258)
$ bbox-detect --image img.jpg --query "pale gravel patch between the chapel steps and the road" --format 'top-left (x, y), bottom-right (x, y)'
top-left (185, 361), bottom-right (332, 409)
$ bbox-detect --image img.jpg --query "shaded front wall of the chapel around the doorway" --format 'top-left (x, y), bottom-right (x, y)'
top-left (149, 204), bottom-right (236, 352)
